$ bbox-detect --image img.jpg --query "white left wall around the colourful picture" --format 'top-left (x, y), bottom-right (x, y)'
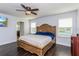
top-left (0, 13), bottom-right (17, 45)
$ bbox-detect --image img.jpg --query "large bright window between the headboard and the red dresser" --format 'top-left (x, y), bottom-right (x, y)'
top-left (58, 18), bottom-right (72, 37)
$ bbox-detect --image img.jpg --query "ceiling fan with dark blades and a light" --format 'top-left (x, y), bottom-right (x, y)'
top-left (16, 4), bottom-right (39, 15)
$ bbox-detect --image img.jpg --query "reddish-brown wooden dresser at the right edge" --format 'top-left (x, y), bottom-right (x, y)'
top-left (71, 36), bottom-right (79, 56)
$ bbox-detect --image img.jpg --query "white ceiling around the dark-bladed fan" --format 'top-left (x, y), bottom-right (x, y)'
top-left (0, 3), bottom-right (79, 18)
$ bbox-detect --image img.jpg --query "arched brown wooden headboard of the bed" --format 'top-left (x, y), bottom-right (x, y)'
top-left (37, 24), bottom-right (56, 34)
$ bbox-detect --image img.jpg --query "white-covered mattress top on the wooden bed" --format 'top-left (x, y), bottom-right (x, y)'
top-left (19, 35), bottom-right (52, 49)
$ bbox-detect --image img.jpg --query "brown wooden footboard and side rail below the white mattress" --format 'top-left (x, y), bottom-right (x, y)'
top-left (18, 40), bottom-right (54, 56)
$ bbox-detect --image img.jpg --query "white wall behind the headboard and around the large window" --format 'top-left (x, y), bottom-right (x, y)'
top-left (31, 11), bottom-right (77, 46)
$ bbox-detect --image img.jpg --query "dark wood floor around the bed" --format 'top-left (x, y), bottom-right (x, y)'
top-left (0, 42), bottom-right (71, 56)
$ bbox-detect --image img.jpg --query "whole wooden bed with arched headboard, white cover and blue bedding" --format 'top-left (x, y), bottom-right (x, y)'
top-left (17, 24), bottom-right (56, 56)
